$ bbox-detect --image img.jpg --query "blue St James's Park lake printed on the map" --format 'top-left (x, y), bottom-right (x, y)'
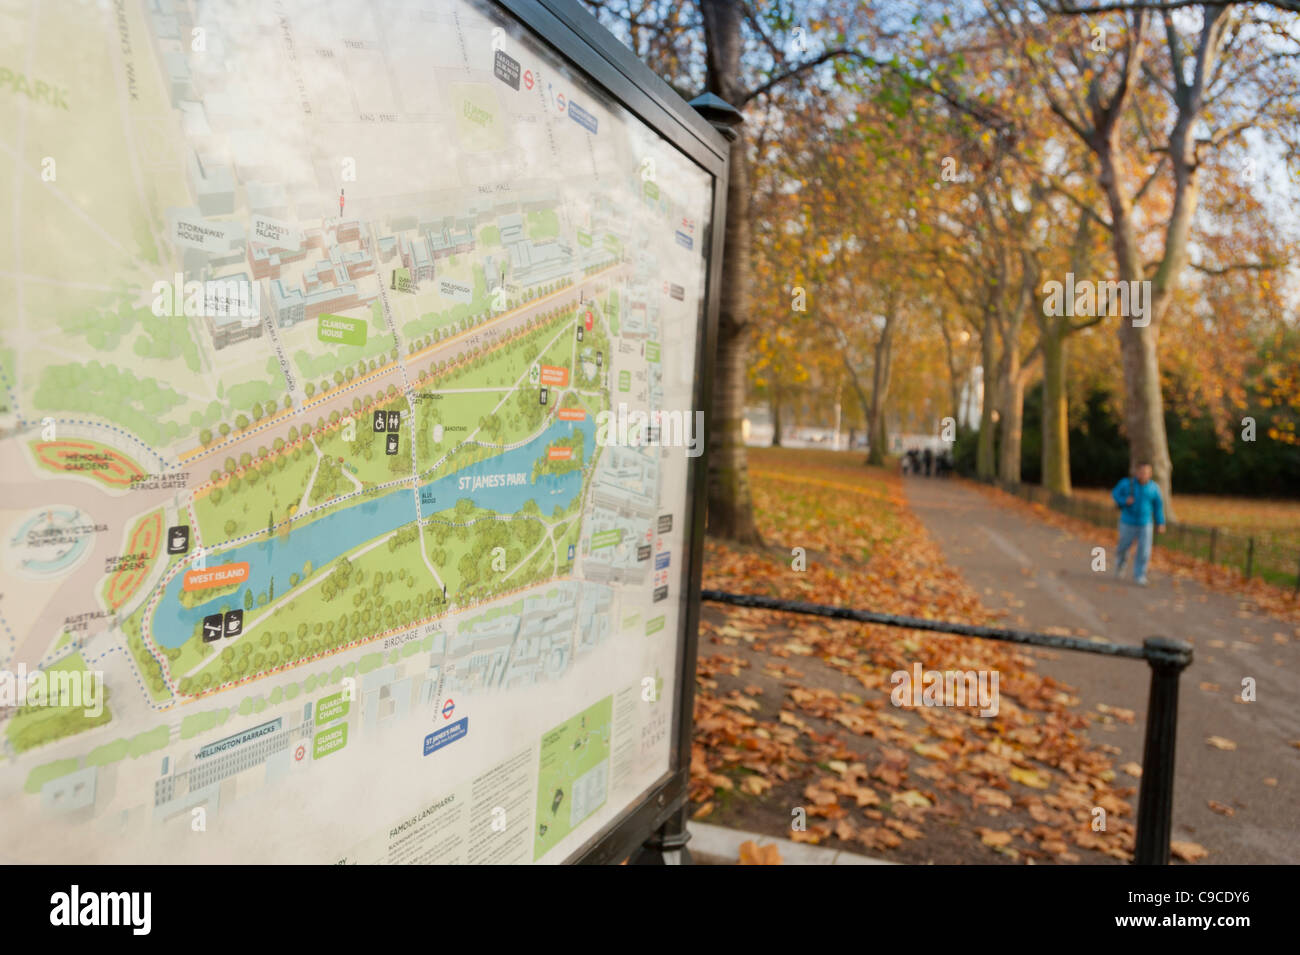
top-left (151, 414), bottom-right (595, 647)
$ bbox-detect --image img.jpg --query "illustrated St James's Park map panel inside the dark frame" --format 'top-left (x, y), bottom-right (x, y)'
top-left (0, 0), bottom-right (715, 863)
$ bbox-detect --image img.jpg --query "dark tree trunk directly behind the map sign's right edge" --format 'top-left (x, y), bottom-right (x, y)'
top-left (701, 0), bottom-right (762, 544)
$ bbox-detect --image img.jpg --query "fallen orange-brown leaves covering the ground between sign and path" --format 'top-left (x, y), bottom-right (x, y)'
top-left (690, 451), bottom-right (1140, 863)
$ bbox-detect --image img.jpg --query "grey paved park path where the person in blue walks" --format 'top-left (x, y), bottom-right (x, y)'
top-left (904, 477), bottom-right (1300, 864)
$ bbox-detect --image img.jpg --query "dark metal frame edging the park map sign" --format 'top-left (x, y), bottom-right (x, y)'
top-left (494, 0), bottom-right (731, 864)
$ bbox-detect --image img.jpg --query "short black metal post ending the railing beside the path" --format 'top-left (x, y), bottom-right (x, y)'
top-left (1134, 637), bottom-right (1192, 865)
